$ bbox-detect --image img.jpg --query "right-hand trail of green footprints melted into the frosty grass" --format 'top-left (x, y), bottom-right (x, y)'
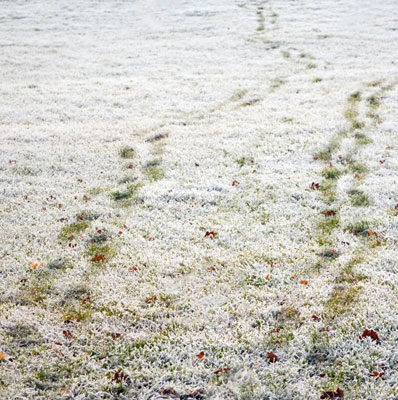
top-left (309, 79), bottom-right (393, 387)
